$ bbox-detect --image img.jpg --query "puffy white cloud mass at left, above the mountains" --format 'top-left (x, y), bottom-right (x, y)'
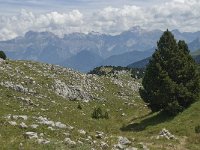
top-left (0, 10), bottom-right (83, 40)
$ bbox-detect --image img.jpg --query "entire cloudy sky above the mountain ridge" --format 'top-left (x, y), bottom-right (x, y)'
top-left (0, 0), bottom-right (200, 40)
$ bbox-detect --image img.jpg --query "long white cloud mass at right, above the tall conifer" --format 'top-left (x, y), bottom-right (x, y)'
top-left (90, 0), bottom-right (200, 33)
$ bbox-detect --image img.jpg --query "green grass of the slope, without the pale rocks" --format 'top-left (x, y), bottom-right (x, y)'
top-left (0, 61), bottom-right (200, 150)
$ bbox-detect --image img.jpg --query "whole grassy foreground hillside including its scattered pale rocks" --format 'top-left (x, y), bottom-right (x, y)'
top-left (0, 60), bottom-right (200, 150)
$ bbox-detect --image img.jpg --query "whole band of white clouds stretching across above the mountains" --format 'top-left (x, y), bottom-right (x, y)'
top-left (0, 0), bottom-right (200, 40)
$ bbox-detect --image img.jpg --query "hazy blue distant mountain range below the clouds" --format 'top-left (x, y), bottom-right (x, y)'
top-left (0, 27), bottom-right (200, 72)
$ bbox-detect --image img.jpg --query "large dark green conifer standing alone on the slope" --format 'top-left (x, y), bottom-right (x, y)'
top-left (140, 30), bottom-right (200, 115)
